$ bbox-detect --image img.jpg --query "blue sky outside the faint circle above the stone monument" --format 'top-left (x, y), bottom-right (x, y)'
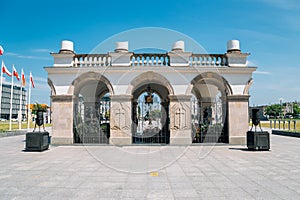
top-left (0, 0), bottom-right (300, 105)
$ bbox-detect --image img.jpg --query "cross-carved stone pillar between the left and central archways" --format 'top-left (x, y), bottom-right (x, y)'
top-left (109, 95), bottom-right (132, 145)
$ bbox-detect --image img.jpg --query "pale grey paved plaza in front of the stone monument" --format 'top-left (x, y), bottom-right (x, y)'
top-left (0, 129), bottom-right (300, 200)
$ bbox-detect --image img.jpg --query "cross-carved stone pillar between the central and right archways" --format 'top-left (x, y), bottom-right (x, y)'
top-left (169, 95), bottom-right (192, 145)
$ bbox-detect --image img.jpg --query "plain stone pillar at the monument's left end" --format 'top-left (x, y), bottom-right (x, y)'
top-left (51, 95), bottom-right (74, 144)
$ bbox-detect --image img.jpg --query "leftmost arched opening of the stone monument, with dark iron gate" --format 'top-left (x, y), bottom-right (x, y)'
top-left (73, 73), bottom-right (112, 144)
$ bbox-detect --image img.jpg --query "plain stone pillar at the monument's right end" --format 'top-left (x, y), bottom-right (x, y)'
top-left (227, 95), bottom-right (250, 145)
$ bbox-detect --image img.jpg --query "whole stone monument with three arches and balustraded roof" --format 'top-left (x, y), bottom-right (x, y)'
top-left (45, 40), bottom-right (256, 145)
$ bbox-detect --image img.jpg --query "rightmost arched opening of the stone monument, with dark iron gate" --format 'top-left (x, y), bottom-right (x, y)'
top-left (191, 72), bottom-right (231, 143)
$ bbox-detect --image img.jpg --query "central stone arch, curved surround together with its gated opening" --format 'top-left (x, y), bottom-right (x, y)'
top-left (127, 71), bottom-right (174, 144)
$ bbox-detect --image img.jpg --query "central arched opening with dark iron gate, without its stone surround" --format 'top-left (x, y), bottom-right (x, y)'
top-left (132, 83), bottom-right (170, 144)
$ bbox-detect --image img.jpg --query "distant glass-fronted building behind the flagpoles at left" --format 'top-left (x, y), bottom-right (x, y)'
top-left (0, 83), bottom-right (27, 120)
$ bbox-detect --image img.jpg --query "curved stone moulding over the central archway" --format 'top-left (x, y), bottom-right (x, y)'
top-left (126, 71), bottom-right (174, 95)
